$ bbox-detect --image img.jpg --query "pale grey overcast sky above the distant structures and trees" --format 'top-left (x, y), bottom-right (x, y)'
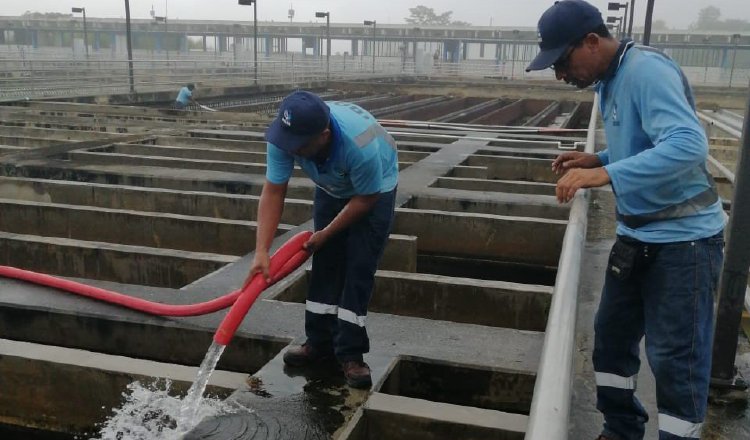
top-left (5, 0), bottom-right (750, 29)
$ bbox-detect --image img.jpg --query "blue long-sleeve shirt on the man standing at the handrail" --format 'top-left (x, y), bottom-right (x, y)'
top-left (598, 46), bottom-right (726, 243)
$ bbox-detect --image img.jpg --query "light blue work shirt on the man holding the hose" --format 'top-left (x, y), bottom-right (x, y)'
top-left (266, 101), bottom-right (398, 199)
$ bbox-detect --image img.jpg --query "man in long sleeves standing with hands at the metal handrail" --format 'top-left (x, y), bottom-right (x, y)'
top-left (527, 0), bottom-right (726, 440)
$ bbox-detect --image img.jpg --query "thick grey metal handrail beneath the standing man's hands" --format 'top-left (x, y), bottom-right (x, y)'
top-left (524, 94), bottom-right (599, 440)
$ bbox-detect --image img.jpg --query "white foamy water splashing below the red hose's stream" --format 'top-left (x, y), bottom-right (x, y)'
top-left (91, 379), bottom-right (249, 440)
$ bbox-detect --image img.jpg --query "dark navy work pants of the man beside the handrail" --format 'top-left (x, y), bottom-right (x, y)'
top-left (593, 233), bottom-right (724, 440)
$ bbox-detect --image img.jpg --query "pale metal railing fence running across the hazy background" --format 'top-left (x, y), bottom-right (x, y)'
top-left (0, 45), bottom-right (750, 100)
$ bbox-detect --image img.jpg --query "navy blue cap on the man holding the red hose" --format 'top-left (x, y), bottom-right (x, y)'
top-left (266, 90), bottom-right (331, 153)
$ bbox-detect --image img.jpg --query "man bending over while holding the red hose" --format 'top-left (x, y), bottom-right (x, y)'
top-left (248, 91), bottom-right (398, 388)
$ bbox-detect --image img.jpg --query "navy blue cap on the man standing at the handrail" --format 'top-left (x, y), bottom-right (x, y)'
top-left (526, 0), bottom-right (604, 72)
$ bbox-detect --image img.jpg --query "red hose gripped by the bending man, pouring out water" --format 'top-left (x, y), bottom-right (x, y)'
top-left (0, 231), bottom-right (312, 324)
